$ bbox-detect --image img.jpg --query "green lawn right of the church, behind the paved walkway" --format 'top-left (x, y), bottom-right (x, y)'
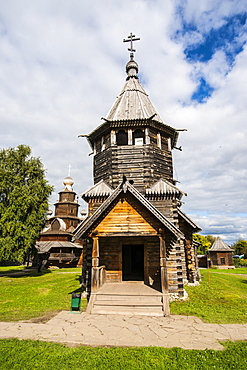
top-left (171, 269), bottom-right (247, 324)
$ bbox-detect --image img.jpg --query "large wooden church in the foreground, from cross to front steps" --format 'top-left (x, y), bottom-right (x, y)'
top-left (74, 34), bottom-right (200, 315)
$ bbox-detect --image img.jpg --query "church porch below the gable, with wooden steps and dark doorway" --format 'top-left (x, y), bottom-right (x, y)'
top-left (84, 236), bottom-right (169, 316)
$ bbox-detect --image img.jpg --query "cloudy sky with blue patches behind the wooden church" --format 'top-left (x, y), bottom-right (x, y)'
top-left (0, 0), bottom-right (247, 245)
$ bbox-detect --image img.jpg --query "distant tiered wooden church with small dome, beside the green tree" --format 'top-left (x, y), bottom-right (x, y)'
top-left (35, 176), bottom-right (82, 267)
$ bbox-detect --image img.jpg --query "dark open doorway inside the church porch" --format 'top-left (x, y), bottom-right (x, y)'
top-left (122, 244), bottom-right (144, 281)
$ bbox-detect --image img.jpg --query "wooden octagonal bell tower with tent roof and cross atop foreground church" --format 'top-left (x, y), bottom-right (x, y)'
top-left (83, 34), bottom-right (178, 194)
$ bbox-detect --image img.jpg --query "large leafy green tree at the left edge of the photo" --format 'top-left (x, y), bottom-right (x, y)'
top-left (0, 145), bottom-right (53, 262)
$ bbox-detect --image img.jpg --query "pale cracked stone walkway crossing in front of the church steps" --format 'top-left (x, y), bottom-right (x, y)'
top-left (0, 311), bottom-right (247, 350)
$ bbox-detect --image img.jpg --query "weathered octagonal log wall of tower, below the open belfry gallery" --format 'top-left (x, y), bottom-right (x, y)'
top-left (94, 145), bottom-right (173, 193)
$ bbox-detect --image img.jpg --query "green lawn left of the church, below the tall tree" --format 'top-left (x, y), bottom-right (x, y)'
top-left (0, 267), bottom-right (86, 321)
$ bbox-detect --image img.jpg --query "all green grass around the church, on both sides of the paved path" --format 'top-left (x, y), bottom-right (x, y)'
top-left (0, 267), bottom-right (247, 370)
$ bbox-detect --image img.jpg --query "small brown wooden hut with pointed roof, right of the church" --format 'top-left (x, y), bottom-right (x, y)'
top-left (208, 236), bottom-right (234, 269)
